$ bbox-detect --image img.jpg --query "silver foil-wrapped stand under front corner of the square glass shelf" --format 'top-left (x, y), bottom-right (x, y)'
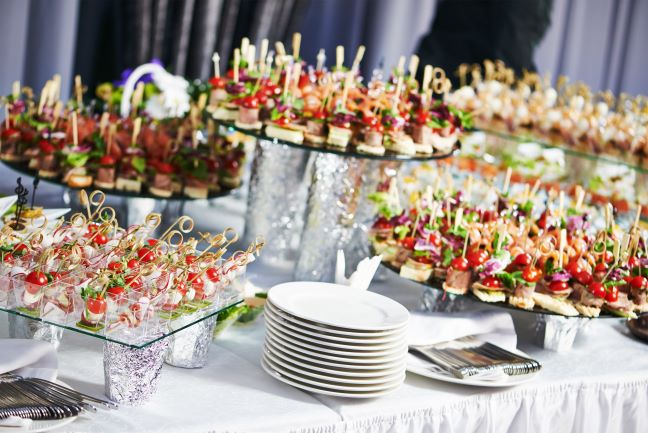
top-left (104, 338), bottom-right (169, 406)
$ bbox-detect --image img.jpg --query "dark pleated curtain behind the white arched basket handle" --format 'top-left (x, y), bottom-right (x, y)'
top-left (74, 0), bottom-right (309, 88)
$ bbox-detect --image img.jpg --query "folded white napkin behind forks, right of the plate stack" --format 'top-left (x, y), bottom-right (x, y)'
top-left (407, 310), bottom-right (517, 350)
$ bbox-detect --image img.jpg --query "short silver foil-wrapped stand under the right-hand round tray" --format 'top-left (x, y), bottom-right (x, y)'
top-left (535, 314), bottom-right (591, 352)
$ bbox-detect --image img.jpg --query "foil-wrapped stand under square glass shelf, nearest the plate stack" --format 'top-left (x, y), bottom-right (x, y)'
top-left (164, 314), bottom-right (217, 368)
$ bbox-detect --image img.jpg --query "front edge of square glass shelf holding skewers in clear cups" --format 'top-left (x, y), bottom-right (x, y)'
top-left (0, 292), bottom-right (243, 349)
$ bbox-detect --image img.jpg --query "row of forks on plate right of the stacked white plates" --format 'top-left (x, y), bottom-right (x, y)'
top-left (408, 337), bottom-right (542, 379)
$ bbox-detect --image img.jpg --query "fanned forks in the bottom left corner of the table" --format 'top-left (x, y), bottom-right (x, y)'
top-left (0, 373), bottom-right (117, 420)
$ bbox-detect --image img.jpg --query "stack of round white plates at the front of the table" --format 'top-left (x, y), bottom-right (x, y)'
top-left (261, 282), bottom-right (409, 398)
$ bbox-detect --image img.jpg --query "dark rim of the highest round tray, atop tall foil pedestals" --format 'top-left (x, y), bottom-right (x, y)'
top-left (217, 121), bottom-right (461, 161)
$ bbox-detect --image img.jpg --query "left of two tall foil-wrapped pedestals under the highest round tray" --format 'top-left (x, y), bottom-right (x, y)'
top-left (243, 139), bottom-right (310, 260)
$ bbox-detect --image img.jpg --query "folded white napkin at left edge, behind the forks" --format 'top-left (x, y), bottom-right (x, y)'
top-left (0, 338), bottom-right (58, 380)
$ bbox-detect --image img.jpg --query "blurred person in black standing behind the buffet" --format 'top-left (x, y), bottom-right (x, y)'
top-left (417, 0), bottom-right (553, 82)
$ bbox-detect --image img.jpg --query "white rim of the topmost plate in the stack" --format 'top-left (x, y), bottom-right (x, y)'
top-left (268, 281), bottom-right (410, 331)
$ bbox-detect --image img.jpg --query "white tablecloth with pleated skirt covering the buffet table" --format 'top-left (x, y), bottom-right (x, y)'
top-left (0, 266), bottom-right (648, 433)
